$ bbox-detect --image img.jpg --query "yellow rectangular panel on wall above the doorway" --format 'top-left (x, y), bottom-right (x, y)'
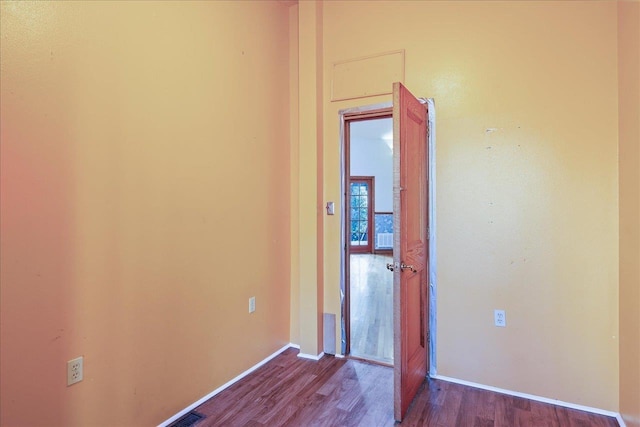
top-left (331, 50), bottom-right (404, 101)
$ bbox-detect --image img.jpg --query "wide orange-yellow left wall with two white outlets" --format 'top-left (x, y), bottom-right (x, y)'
top-left (0, 1), bottom-right (290, 426)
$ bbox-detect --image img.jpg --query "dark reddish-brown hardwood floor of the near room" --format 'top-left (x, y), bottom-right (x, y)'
top-left (191, 349), bottom-right (618, 427)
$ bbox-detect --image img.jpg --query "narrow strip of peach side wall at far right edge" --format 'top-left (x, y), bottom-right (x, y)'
top-left (618, 1), bottom-right (640, 427)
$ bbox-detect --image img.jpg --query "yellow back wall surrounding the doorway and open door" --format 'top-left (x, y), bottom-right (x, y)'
top-left (323, 1), bottom-right (619, 411)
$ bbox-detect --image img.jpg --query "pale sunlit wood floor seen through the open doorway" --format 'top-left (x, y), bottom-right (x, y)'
top-left (349, 254), bottom-right (393, 364)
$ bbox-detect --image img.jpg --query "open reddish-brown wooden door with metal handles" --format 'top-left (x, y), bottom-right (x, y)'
top-left (393, 83), bottom-right (429, 421)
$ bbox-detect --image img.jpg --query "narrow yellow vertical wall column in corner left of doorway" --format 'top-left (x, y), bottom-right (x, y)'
top-left (292, 0), bottom-right (324, 357)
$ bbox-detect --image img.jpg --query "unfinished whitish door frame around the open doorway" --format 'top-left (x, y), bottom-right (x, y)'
top-left (338, 98), bottom-right (437, 376)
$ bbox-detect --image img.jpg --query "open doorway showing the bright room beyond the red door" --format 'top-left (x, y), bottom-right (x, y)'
top-left (344, 117), bottom-right (393, 366)
